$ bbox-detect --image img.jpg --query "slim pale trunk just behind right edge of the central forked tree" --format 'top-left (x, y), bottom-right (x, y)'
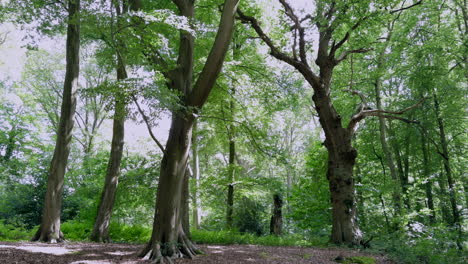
top-left (192, 120), bottom-right (200, 229)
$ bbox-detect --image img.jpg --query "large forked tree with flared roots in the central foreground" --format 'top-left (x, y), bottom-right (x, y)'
top-left (141, 0), bottom-right (239, 263)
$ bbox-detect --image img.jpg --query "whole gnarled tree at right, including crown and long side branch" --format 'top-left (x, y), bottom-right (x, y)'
top-left (238, 0), bottom-right (424, 245)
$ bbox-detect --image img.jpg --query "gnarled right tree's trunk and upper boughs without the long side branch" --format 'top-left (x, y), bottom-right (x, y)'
top-left (238, 0), bottom-right (364, 244)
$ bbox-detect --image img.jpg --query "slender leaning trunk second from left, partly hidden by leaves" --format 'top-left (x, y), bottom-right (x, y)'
top-left (91, 3), bottom-right (128, 242)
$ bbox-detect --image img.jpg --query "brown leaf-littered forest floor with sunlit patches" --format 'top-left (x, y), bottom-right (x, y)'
top-left (0, 241), bottom-right (394, 264)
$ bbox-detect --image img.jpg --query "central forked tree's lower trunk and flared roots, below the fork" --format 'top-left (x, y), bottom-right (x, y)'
top-left (140, 113), bottom-right (197, 262)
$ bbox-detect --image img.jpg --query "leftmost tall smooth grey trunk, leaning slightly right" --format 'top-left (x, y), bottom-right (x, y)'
top-left (32, 0), bottom-right (80, 243)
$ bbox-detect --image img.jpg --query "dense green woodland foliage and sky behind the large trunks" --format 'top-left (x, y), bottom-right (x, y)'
top-left (0, 0), bottom-right (468, 263)
